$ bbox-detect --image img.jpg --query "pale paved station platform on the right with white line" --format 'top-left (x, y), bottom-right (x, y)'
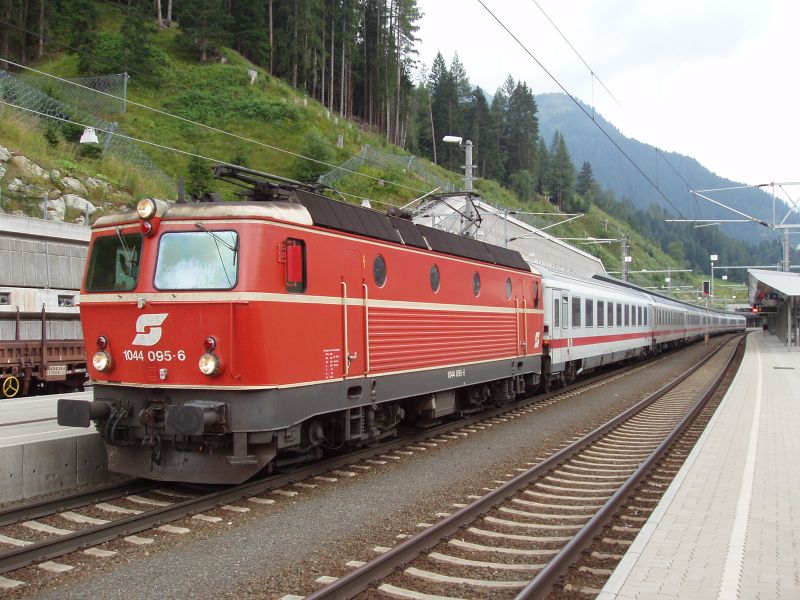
top-left (597, 331), bottom-right (800, 600)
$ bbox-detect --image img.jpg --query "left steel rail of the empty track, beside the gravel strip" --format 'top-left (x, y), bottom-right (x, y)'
top-left (306, 332), bottom-right (740, 600)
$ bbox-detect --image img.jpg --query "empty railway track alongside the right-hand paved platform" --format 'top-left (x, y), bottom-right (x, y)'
top-left (300, 336), bottom-right (743, 600)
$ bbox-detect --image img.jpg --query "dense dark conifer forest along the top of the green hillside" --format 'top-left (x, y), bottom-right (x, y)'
top-left (0, 0), bottom-right (792, 270)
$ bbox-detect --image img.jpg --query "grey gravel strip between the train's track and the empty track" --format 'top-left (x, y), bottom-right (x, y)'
top-left (10, 344), bottom-right (724, 600)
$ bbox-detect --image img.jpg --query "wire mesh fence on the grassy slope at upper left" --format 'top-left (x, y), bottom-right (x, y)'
top-left (0, 71), bottom-right (175, 187)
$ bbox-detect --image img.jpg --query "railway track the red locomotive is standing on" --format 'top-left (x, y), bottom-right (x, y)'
top-left (0, 344), bottom-right (680, 574)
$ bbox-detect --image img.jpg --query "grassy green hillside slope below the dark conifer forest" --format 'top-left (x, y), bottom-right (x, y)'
top-left (0, 2), bottom-right (740, 304)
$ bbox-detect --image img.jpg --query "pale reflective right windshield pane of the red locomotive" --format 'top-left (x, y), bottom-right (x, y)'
top-left (155, 228), bottom-right (239, 290)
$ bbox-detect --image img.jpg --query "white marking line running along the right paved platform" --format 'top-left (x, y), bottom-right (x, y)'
top-left (717, 352), bottom-right (763, 600)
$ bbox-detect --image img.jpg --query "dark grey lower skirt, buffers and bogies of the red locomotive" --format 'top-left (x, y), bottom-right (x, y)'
top-left (57, 356), bottom-right (541, 483)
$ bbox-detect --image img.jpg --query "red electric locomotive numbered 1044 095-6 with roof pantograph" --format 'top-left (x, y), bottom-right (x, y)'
top-left (58, 167), bottom-right (543, 483)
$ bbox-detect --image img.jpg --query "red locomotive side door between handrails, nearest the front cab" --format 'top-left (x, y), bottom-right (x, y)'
top-left (342, 250), bottom-right (367, 377)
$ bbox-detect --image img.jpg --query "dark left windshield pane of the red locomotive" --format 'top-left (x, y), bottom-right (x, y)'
top-left (85, 231), bottom-right (142, 292)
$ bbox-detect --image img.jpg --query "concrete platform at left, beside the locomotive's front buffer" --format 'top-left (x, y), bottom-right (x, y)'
top-left (0, 391), bottom-right (109, 502)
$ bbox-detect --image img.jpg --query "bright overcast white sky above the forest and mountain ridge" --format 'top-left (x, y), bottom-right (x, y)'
top-left (417, 0), bottom-right (800, 190)
